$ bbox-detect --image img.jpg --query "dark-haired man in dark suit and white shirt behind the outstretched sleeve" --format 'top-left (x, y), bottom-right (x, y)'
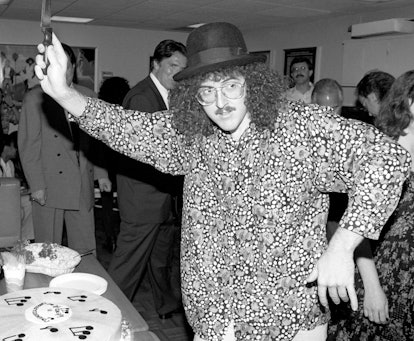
top-left (108, 40), bottom-right (187, 318)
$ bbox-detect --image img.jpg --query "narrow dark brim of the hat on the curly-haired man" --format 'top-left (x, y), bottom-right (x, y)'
top-left (174, 54), bottom-right (266, 81)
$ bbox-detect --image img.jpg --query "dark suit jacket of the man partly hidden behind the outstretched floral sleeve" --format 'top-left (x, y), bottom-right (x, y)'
top-left (118, 76), bottom-right (183, 223)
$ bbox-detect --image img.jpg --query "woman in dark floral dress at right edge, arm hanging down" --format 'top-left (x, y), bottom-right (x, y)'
top-left (330, 70), bottom-right (414, 341)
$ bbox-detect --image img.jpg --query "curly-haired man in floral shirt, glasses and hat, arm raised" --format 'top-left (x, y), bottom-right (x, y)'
top-left (36, 23), bottom-right (411, 341)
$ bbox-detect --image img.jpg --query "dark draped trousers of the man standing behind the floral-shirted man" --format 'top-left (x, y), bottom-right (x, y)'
top-left (108, 177), bottom-right (181, 314)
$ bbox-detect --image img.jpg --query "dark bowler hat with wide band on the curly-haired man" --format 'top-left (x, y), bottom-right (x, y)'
top-left (174, 22), bottom-right (266, 81)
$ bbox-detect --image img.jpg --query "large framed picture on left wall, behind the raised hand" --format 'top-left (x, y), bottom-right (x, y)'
top-left (0, 44), bottom-right (95, 106)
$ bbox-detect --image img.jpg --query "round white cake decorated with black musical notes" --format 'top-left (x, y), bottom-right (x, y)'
top-left (0, 288), bottom-right (122, 341)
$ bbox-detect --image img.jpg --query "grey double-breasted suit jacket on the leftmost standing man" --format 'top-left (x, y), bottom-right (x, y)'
top-left (18, 85), bottom-right (108, 210)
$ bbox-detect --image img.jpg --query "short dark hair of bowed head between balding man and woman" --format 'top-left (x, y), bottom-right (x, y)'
top-left (356, 71), bottom-right (395, 102)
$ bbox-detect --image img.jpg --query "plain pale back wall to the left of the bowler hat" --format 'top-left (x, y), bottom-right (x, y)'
top-left (0, 20), bottom-right (187, 90)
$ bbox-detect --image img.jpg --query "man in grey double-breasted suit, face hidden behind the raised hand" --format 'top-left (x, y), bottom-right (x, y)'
top-left (18, 45), bottom-right (111, 253)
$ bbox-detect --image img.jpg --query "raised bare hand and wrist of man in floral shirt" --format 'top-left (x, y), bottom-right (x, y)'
top-left (35, 33), bottom-right (87, 116)
